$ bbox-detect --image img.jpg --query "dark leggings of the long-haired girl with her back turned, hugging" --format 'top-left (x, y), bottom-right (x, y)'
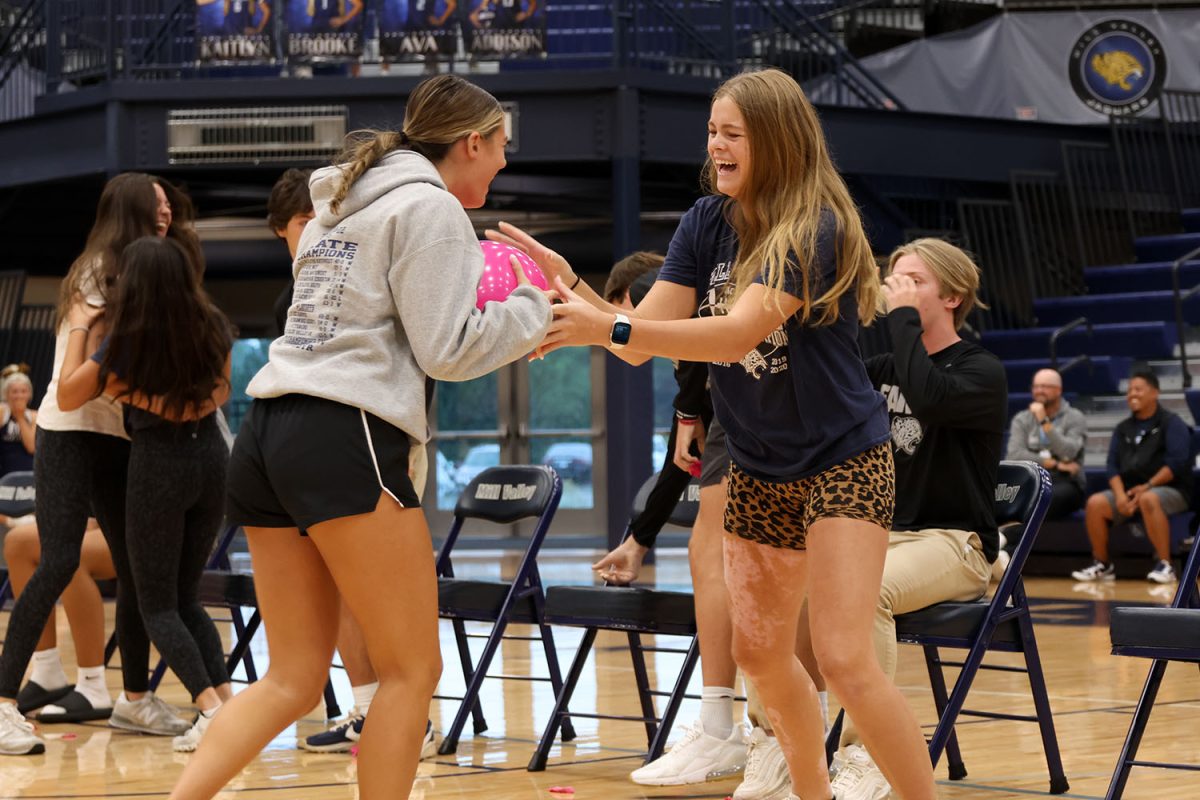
top-left (126, 414), bottom-right (229, 699)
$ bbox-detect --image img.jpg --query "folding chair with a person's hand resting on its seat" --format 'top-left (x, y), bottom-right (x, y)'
top-left (528, 475), bottom-right (700, 772)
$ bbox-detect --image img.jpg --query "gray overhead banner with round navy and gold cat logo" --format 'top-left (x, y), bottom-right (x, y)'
top-left (805, 8), bottom-right (1200, 124)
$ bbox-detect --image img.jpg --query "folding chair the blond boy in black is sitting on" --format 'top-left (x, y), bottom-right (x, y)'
top-left (895, 462), bottom-right (1070, 794)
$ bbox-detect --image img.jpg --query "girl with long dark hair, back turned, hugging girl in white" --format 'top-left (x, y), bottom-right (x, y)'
top-left (58, 236), bottom-right (232, 752)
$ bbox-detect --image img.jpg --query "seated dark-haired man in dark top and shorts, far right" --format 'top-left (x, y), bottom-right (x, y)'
top-left (1070, 371), bottom-right (1192, 583)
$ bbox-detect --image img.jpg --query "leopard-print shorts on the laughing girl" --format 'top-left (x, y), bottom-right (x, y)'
top-left (725, 443), bottom-right (896, 551)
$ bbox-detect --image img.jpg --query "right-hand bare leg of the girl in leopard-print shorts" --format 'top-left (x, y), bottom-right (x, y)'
top-left (806, 518), bottom-right (936, 800)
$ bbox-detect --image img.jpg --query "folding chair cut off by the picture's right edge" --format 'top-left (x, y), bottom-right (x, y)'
top-left (1104, 527), bottom-right (1200, 800)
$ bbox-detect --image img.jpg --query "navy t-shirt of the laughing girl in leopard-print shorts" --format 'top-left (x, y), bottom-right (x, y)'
top-left (659, 197), bottom-right (889, 481)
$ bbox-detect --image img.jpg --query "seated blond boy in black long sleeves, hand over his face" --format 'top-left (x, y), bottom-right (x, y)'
top-left (833, 239), bottom-right (1008, 800)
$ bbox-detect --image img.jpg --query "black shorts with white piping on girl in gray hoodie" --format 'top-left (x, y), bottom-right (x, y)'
top-left (227, 395), bottom-right (420, 530)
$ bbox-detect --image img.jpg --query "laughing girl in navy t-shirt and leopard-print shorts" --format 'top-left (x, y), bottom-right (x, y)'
top-left (494, 70), bottom-right (935, 800)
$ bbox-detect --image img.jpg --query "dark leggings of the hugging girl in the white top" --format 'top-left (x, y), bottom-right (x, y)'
top-left (0, 428), bottom-right (150, 697)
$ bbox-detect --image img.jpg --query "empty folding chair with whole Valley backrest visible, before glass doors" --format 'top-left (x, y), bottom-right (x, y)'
top-left (434, 467), bottom-right (575, 756)
